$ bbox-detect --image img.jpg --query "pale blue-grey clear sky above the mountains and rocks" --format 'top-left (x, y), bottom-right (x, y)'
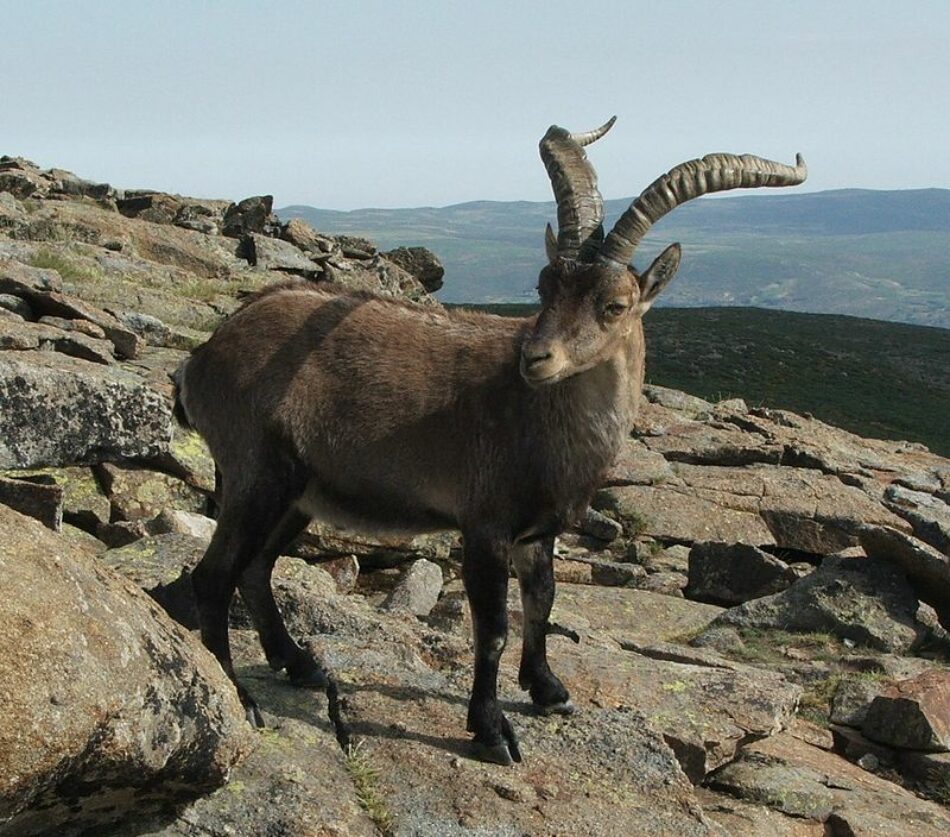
top-left (0, 0), bottom-right (950, 209)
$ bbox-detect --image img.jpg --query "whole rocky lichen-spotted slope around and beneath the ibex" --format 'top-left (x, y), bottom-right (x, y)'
top-left (0, 157), bottom-right (950, 837)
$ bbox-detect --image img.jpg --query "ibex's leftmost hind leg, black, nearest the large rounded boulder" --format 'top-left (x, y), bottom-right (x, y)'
top-left (191, 475), bottom-right (308, 727)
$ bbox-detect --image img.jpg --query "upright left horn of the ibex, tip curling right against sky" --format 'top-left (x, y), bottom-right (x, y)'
top-left (540, 116), bottom-right (617, 258)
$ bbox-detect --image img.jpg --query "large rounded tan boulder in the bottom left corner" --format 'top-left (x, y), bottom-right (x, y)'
top-left (0, 506), bottom-right (249, 835)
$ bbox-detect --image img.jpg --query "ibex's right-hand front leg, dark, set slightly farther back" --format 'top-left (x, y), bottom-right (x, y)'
top-left (512, 538), bottom-right (574, 714)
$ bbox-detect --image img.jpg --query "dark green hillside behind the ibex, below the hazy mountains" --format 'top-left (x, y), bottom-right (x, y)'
top-left (448, 305), bottom-right (950, 456)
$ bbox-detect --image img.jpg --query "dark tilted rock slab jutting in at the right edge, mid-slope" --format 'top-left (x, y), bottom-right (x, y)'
top-left (859, 526), bottom-right (950, 630)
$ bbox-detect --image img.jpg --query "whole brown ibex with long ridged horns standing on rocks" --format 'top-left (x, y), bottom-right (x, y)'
top-left (176, 119), bottom-right (806, 764)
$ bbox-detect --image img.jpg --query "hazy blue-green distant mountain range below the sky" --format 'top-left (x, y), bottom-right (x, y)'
top-left (278, 189), bottom-right (950, 328)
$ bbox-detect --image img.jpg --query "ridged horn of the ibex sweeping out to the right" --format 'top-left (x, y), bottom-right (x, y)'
top-left (598, 154), bottom-right (808, 265)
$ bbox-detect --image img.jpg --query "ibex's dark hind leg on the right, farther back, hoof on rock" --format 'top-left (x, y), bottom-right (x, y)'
top-left (238, 508), bottom-right (327, 686)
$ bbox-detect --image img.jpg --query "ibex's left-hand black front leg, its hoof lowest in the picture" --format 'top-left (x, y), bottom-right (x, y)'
top-left (462, 533), bottom-right (521, 765)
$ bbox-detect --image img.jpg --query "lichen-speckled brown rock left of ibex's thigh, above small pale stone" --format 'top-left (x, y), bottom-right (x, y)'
top-left (96, 462), bottom-right (207, 520)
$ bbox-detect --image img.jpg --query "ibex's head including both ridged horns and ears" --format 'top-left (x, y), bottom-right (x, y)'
top-left (521, 117), bottom-right (808, 385)
